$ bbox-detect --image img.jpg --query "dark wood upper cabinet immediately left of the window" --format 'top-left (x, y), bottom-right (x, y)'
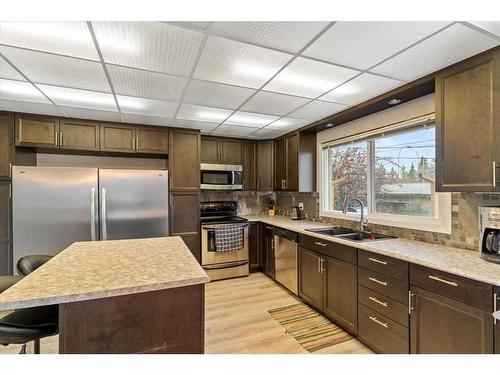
top-left (274, 132), bottom-right (316, 192)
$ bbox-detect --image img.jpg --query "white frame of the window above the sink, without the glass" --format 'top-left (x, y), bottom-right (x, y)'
top-left (318, 114), bottom-right (451, 234)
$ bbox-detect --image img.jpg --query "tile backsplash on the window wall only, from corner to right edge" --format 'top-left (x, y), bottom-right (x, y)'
top-left (275, 192), bottom-right (500, 251)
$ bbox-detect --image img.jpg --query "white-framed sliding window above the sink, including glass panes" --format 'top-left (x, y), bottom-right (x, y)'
top-left (320, 118), bottom-right (451, 233)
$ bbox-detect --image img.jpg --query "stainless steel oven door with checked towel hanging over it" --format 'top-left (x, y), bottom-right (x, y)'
top-left (201, 224), bottom-right (248, 266)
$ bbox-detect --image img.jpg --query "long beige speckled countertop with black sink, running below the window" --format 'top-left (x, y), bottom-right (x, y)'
top-left (243, 215), bottom-right (500, 286)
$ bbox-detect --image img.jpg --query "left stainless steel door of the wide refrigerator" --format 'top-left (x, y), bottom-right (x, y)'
top-left (12, 167), bottom-right (98, 269)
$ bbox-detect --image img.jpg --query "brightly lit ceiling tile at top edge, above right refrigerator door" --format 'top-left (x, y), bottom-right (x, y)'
top-left (92, 22), bottom-right (203, 76)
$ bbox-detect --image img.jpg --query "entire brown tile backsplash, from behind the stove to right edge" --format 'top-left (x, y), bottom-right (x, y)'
top-left (201, 190), bottom-right (500, 251)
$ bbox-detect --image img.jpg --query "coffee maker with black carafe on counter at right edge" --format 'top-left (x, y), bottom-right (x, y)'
top-left (479, 207), bottom-right (500, 263)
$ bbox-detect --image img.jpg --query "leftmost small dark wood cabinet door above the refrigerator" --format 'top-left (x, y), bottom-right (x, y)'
top-left (16, 115), bottom-right (59, 148)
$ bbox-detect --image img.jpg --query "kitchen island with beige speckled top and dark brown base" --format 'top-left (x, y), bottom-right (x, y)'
top-left (0, 237), bottom-right (210, 354)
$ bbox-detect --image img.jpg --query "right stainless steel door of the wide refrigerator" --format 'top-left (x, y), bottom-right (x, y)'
top-left (99, 169), bottom-right (168, 240)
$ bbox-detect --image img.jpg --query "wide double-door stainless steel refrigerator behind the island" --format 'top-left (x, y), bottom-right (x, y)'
top-left (12, 167), bottom-right (168, 269)
